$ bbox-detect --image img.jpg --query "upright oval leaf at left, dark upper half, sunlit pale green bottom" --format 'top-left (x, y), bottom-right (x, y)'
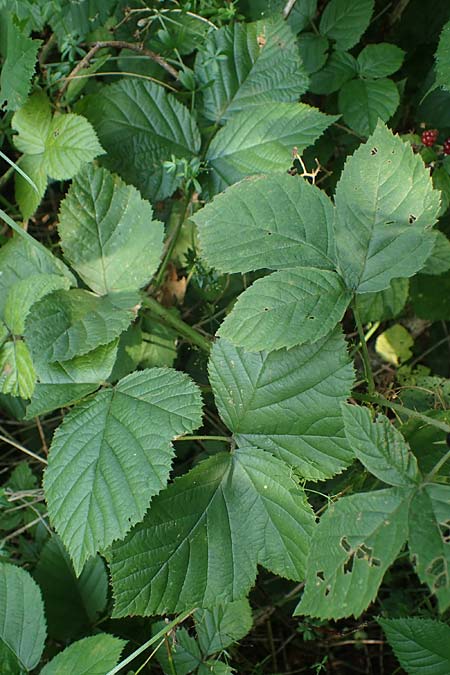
top-left (58, 166), bottom-right (164, 295)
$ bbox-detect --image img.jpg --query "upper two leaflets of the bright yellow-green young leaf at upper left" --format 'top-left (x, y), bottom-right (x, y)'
top-left (11, 92), bottom-right (102, 180)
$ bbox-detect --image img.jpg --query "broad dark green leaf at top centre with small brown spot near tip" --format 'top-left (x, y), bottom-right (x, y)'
top-left (195, 16), bottom-right (308, 124)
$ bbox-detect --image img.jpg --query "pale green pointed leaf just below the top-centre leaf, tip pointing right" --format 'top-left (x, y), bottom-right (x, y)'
top-left (206, 102), bottom-right (337, 194)
